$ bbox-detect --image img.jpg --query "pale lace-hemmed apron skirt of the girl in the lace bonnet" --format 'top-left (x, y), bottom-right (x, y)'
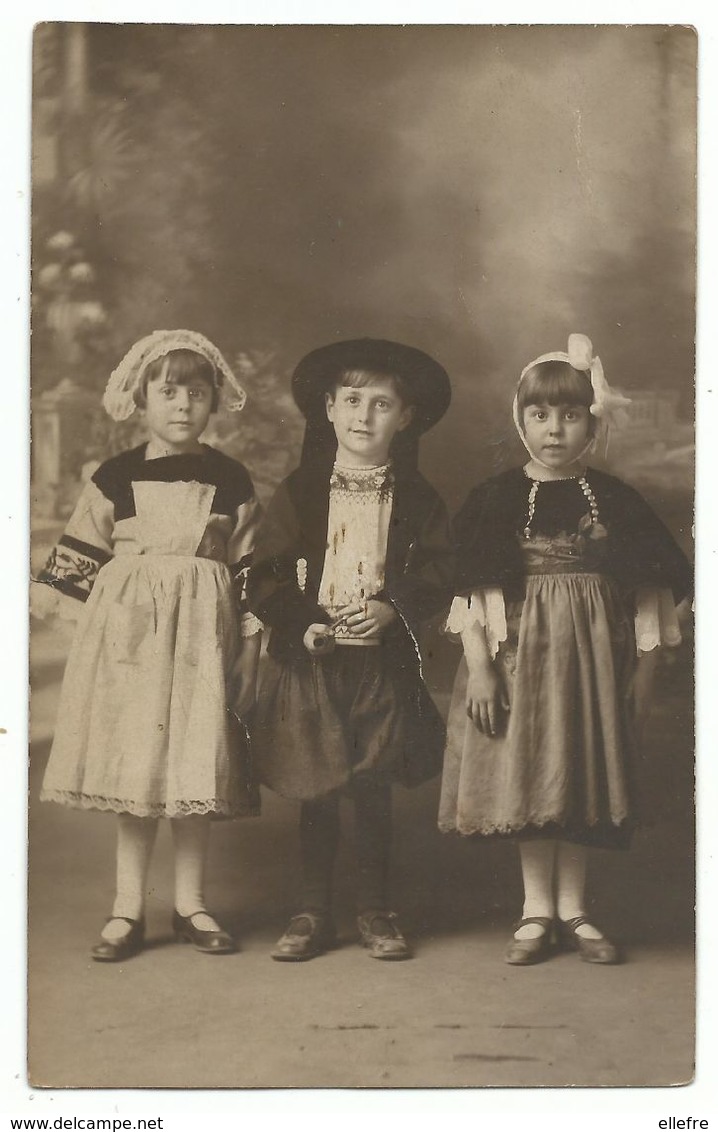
top-left (41, 555), bottom-right (257, 817)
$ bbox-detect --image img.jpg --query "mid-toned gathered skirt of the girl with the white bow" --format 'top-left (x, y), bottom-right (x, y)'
top-left (438, 573), bottom-right (635, 847)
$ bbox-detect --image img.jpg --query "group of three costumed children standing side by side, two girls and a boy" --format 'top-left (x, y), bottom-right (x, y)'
top-left (32, 332), bottom-right (690, 964)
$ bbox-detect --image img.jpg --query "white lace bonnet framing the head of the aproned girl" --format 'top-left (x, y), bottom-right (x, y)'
top-left (102, 331), bottom-right (247, 421)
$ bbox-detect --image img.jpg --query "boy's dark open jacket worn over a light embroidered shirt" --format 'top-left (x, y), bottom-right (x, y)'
top-left (247, 466), bottom-right (454, 677)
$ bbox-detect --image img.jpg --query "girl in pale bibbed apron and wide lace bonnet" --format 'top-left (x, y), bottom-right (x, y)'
top-left (33, 331), bottom-right (262, 962)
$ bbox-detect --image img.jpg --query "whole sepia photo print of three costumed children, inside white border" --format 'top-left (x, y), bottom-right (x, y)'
top-left (20, 19), bottom-right (699, 1095)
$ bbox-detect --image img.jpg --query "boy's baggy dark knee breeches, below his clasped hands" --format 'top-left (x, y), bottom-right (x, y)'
top-left (253, 645), bottom-right (445, 800)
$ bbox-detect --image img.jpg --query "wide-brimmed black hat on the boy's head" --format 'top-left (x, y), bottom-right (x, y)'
top-left (292, 338), bottom-right (451, 436)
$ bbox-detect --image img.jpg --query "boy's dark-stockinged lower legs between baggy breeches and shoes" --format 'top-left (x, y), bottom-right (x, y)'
top-left (299, 771), bottom-right (392, 915)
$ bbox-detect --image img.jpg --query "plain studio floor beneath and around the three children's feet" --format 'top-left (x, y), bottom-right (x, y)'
top-left (28, 626), bottom-right (694, 1089)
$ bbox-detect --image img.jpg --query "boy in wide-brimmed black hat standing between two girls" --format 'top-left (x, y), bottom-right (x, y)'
top-left (248, 338), bottom-right (452, 961)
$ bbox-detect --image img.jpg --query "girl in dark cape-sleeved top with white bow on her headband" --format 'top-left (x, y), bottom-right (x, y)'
top-left (439, 334), bottom-right (691, 966)
